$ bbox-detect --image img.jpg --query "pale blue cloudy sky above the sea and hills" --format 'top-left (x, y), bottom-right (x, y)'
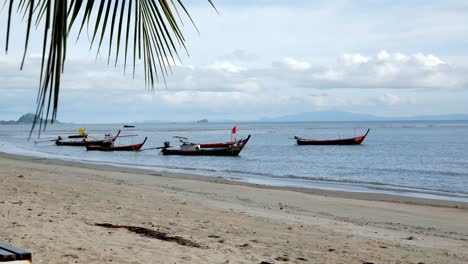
top-left (0, 0), bottom-right (468, 123)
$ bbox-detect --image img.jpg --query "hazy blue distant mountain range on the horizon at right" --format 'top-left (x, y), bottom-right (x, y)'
top-left (257, 111), bottom-right (468, 122)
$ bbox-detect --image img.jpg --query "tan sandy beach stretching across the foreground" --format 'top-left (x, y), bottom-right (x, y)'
top-left (0, 154), bottom-right (468, 264)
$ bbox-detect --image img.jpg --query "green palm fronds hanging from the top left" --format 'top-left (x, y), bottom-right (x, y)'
top-left (5, 0), bottom-right (215, 135)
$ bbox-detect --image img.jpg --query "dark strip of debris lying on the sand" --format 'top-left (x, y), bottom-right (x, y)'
top-left (94, 223), bottom-right (205, 248)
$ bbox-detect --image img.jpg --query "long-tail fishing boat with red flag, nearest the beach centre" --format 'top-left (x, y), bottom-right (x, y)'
top-left (161, 135), bottom-right (251, 156)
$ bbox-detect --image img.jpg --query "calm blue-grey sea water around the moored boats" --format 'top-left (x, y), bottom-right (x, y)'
top-left (0, 121), bottom-right (468, 202)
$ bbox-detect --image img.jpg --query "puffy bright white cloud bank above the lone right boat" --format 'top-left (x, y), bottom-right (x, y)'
top-left (270, 50), bottom-right (468, 89)
